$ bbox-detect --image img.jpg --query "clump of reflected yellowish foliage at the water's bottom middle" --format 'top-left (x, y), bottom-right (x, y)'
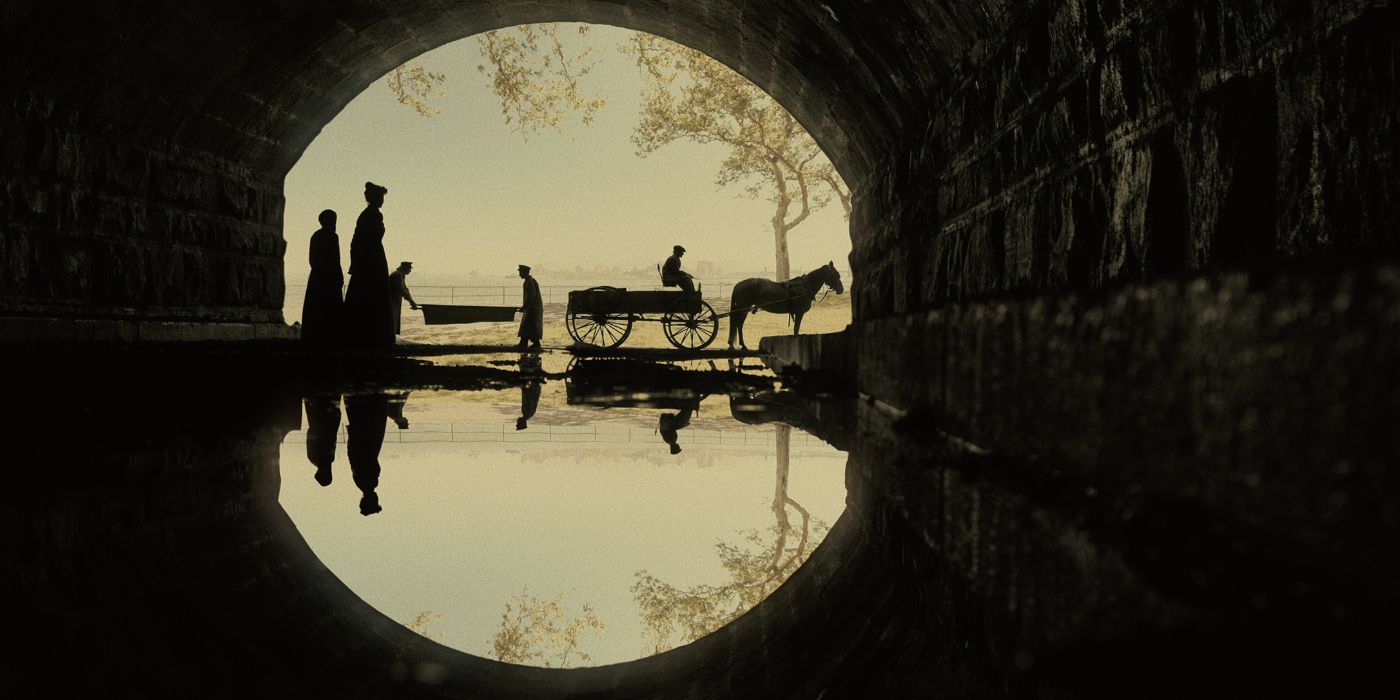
top-left (491, 588), bottom-right (603, 668)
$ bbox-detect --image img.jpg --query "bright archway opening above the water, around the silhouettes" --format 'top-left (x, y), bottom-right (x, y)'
top-left (283, 24), bottom-right (853, 347)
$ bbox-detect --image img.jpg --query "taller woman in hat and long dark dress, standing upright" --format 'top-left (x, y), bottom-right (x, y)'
top-left (344, 182), bottom-right (393, 346)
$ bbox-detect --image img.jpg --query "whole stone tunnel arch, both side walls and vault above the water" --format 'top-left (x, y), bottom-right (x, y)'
top-left (0, 0), bottom-right (1400, 694)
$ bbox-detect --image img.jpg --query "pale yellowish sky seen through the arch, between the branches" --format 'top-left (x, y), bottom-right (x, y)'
top-left (284, 27), bottom-right (850, 284)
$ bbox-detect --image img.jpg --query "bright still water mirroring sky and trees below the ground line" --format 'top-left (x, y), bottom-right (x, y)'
top-left (280, 379), bottom-right (846, 666)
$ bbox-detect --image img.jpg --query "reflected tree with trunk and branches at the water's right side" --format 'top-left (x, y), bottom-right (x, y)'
top-left (631, 424), bottom-right (827, 654)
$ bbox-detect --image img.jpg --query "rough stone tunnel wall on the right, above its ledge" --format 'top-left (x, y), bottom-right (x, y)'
top-left (851, 0), bottom-right (1400, 318)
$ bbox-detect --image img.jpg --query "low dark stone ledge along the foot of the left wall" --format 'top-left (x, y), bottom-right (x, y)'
top-left (0, 316), bottom-right (301, 347)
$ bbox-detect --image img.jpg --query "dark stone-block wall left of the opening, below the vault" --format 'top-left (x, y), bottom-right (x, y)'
top-left (0, 104), bottom-right (284, 322)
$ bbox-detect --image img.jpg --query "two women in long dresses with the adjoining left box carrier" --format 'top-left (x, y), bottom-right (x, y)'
top-left (301, 182), bottom-right (419, 347)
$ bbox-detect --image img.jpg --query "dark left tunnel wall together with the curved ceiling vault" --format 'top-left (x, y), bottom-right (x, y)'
top-left (0, 0), bottom-right (1014, 340)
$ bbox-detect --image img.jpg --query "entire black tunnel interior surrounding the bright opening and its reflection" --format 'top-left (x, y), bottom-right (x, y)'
top-left (0, 0), bottom-right (1400, 697)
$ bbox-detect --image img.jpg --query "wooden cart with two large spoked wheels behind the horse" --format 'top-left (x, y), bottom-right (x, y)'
top-left (564, 287), bottom-right (720, 350)
